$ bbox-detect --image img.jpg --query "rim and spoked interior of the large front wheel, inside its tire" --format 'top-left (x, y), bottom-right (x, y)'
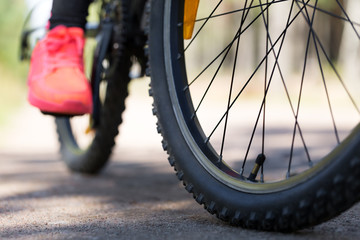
top-left (164, 0), bottom-right (360, 193)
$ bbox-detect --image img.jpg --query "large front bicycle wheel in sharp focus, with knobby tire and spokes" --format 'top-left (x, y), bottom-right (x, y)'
top-left (149, 0), bottom-right (360, 231)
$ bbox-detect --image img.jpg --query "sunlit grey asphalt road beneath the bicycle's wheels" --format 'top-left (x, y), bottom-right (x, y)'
top-left (0, 79), bottom-right (360, 239)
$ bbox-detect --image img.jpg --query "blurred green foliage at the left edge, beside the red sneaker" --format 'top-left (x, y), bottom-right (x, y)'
top-left (0, 0), bottom-right (28, 124)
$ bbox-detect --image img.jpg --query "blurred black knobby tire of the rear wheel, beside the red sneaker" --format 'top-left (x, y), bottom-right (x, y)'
top-left (55, 1), bottom-right (132, 174)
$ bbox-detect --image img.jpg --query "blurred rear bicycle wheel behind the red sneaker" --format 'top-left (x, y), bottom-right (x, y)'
top-left (55, 1), bottom-right (131, 174)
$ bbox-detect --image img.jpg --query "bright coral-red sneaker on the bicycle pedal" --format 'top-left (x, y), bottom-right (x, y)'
top-left (28, 26), bottom-right (92, 115)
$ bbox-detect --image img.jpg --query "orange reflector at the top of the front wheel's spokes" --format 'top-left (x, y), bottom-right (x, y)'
top-left (184, 0), bottom-right (200, 39)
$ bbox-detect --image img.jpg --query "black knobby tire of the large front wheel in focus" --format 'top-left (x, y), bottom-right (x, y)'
top-left (149, 0), bottom-right (360, 231)
